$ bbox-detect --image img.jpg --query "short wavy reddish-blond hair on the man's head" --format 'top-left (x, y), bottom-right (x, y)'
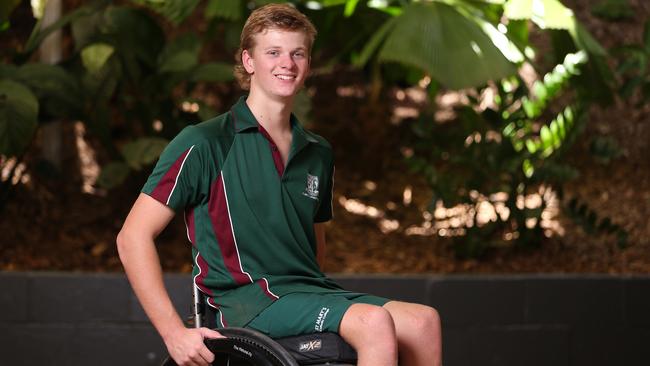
top-left (235, 4), bottom-right (316, 90)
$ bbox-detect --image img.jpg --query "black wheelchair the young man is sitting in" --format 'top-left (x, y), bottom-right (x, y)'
top-left (162, 286), bottom-right (357, 366)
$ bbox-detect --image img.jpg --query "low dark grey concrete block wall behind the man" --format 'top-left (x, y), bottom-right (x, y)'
top-left (0, 272), bottom-right (650, 366)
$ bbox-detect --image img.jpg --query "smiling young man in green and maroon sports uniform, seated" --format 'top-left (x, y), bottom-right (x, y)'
top-left (117, 5), bottom-right (441, 366)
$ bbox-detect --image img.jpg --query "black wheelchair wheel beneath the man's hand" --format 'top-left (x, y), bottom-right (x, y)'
top-left (163, 328), bottom-right (298, 366)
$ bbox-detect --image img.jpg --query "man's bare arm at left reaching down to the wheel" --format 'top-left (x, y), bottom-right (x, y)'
top-left (117, 194), bottom-right (220, 365)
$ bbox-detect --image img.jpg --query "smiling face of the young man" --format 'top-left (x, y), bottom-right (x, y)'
top-left (242, 29), bottom-right (309, 99)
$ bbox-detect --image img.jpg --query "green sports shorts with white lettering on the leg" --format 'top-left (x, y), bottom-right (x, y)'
top-left (246, 292), bottom-right (389, 338)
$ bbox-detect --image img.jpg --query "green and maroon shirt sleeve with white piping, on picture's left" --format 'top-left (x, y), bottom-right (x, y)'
top-left (142, 126), bottom-right (201, 211)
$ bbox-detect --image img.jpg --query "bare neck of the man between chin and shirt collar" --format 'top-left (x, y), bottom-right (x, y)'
top-left (246, 90), bottom-right (293, 133)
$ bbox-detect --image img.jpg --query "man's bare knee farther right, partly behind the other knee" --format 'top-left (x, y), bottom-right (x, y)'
top-left (384, 301), bottom-right (442, 366)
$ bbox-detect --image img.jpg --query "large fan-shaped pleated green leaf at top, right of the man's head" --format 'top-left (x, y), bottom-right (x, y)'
top-left (378, 2), bottom-right (516, 89)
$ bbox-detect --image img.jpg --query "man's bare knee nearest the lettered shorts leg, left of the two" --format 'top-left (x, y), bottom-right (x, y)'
top-left (339, 304), bottom-right (397, 366)
